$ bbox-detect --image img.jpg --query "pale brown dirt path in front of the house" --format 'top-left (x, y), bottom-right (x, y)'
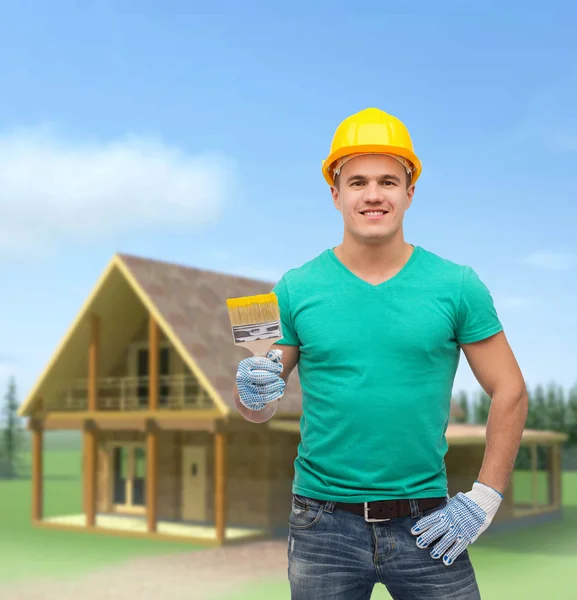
top-left (0, 541), bottom-right (287, 600)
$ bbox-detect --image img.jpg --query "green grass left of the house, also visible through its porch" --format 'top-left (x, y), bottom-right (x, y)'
top-left (0, 449), bottom-right (202, 584)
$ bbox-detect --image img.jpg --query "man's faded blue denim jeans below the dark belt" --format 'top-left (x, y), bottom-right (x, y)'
top-left (288, 495), bottom-right (481, 600)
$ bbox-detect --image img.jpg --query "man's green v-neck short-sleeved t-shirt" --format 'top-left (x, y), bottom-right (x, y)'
top-left (274, 246), bottom-right (502, 502)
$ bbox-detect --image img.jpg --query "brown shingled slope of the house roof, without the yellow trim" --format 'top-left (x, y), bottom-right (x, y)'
top-left (117, 253), bottom-right (302, 415)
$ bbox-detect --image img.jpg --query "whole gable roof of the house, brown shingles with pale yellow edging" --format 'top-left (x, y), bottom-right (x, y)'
top-left (19, 253), bottom-right (302, 416)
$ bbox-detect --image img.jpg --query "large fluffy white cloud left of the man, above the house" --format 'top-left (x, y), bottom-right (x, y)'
top-left (0, 128), bottom-right (234, 255)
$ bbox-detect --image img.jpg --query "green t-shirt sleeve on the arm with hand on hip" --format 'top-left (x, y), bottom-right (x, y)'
top-left (456, 267), bottom-right (503, 344)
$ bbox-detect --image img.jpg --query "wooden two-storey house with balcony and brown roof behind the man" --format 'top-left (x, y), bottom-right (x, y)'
top-left (20, 254), bottom-right (565, 544)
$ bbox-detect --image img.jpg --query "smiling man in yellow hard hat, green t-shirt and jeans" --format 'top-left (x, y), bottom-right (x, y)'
top-left (235, 108), bottom-right (527, 600)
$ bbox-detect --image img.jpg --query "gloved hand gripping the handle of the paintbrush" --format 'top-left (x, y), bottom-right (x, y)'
top-left (236, 349), bottom-right (285, 410)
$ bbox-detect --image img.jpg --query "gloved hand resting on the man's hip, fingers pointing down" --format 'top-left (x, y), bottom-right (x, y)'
top-left (411, 481), bottom-right (503, 566)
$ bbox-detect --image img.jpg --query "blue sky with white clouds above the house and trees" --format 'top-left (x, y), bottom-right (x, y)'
top-left (0, 1), bottom-right (577, 408)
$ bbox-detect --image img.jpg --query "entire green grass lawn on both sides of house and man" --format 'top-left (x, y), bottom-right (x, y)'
top-left (0, 436), bottom-right (577, 600)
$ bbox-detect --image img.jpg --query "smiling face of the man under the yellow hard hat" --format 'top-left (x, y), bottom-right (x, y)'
top-left (331, 154), bottom-right (415, 243)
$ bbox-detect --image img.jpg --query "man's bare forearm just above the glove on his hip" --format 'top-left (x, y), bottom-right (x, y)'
top-left (477, 388), bottom-right (529, 494)
